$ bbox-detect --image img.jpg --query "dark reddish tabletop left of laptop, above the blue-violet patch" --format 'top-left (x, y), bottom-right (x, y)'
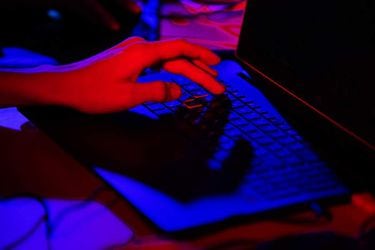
top-left (0, 123), bottom-right (103, 200)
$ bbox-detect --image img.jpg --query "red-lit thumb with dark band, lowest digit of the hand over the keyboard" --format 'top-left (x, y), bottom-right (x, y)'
top-left (128, 81), bottom-right (181, 106)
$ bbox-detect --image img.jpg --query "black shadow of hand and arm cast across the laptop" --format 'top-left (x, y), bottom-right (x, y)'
top-left (23, 96), bottom-right (252, 202)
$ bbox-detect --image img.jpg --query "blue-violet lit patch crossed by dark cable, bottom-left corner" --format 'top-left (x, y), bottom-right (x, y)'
top-left (0, 198), bottom-right (132, 250)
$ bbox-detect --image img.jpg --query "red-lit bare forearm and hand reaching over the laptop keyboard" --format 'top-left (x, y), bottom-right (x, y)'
top-left (0, 38), bottom-right (224, 113)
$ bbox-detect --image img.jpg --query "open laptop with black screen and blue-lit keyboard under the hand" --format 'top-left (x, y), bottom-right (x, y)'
top-left (21, 0), bottom-right (375, 234)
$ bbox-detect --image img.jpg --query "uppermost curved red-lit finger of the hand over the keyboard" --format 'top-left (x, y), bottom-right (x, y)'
top-left (139, 39), bottom-right (220, 67)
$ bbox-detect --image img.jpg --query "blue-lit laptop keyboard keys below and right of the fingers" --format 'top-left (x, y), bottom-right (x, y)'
top-left (140, 67), bottom-right (347, 202)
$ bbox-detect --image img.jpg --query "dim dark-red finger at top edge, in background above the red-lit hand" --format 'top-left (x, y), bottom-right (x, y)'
top-left (85, 0), bottom-right (121, 31)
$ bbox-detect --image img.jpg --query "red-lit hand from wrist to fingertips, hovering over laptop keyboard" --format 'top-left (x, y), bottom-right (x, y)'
top-left (53, 37), bottom-right (225, 113)
